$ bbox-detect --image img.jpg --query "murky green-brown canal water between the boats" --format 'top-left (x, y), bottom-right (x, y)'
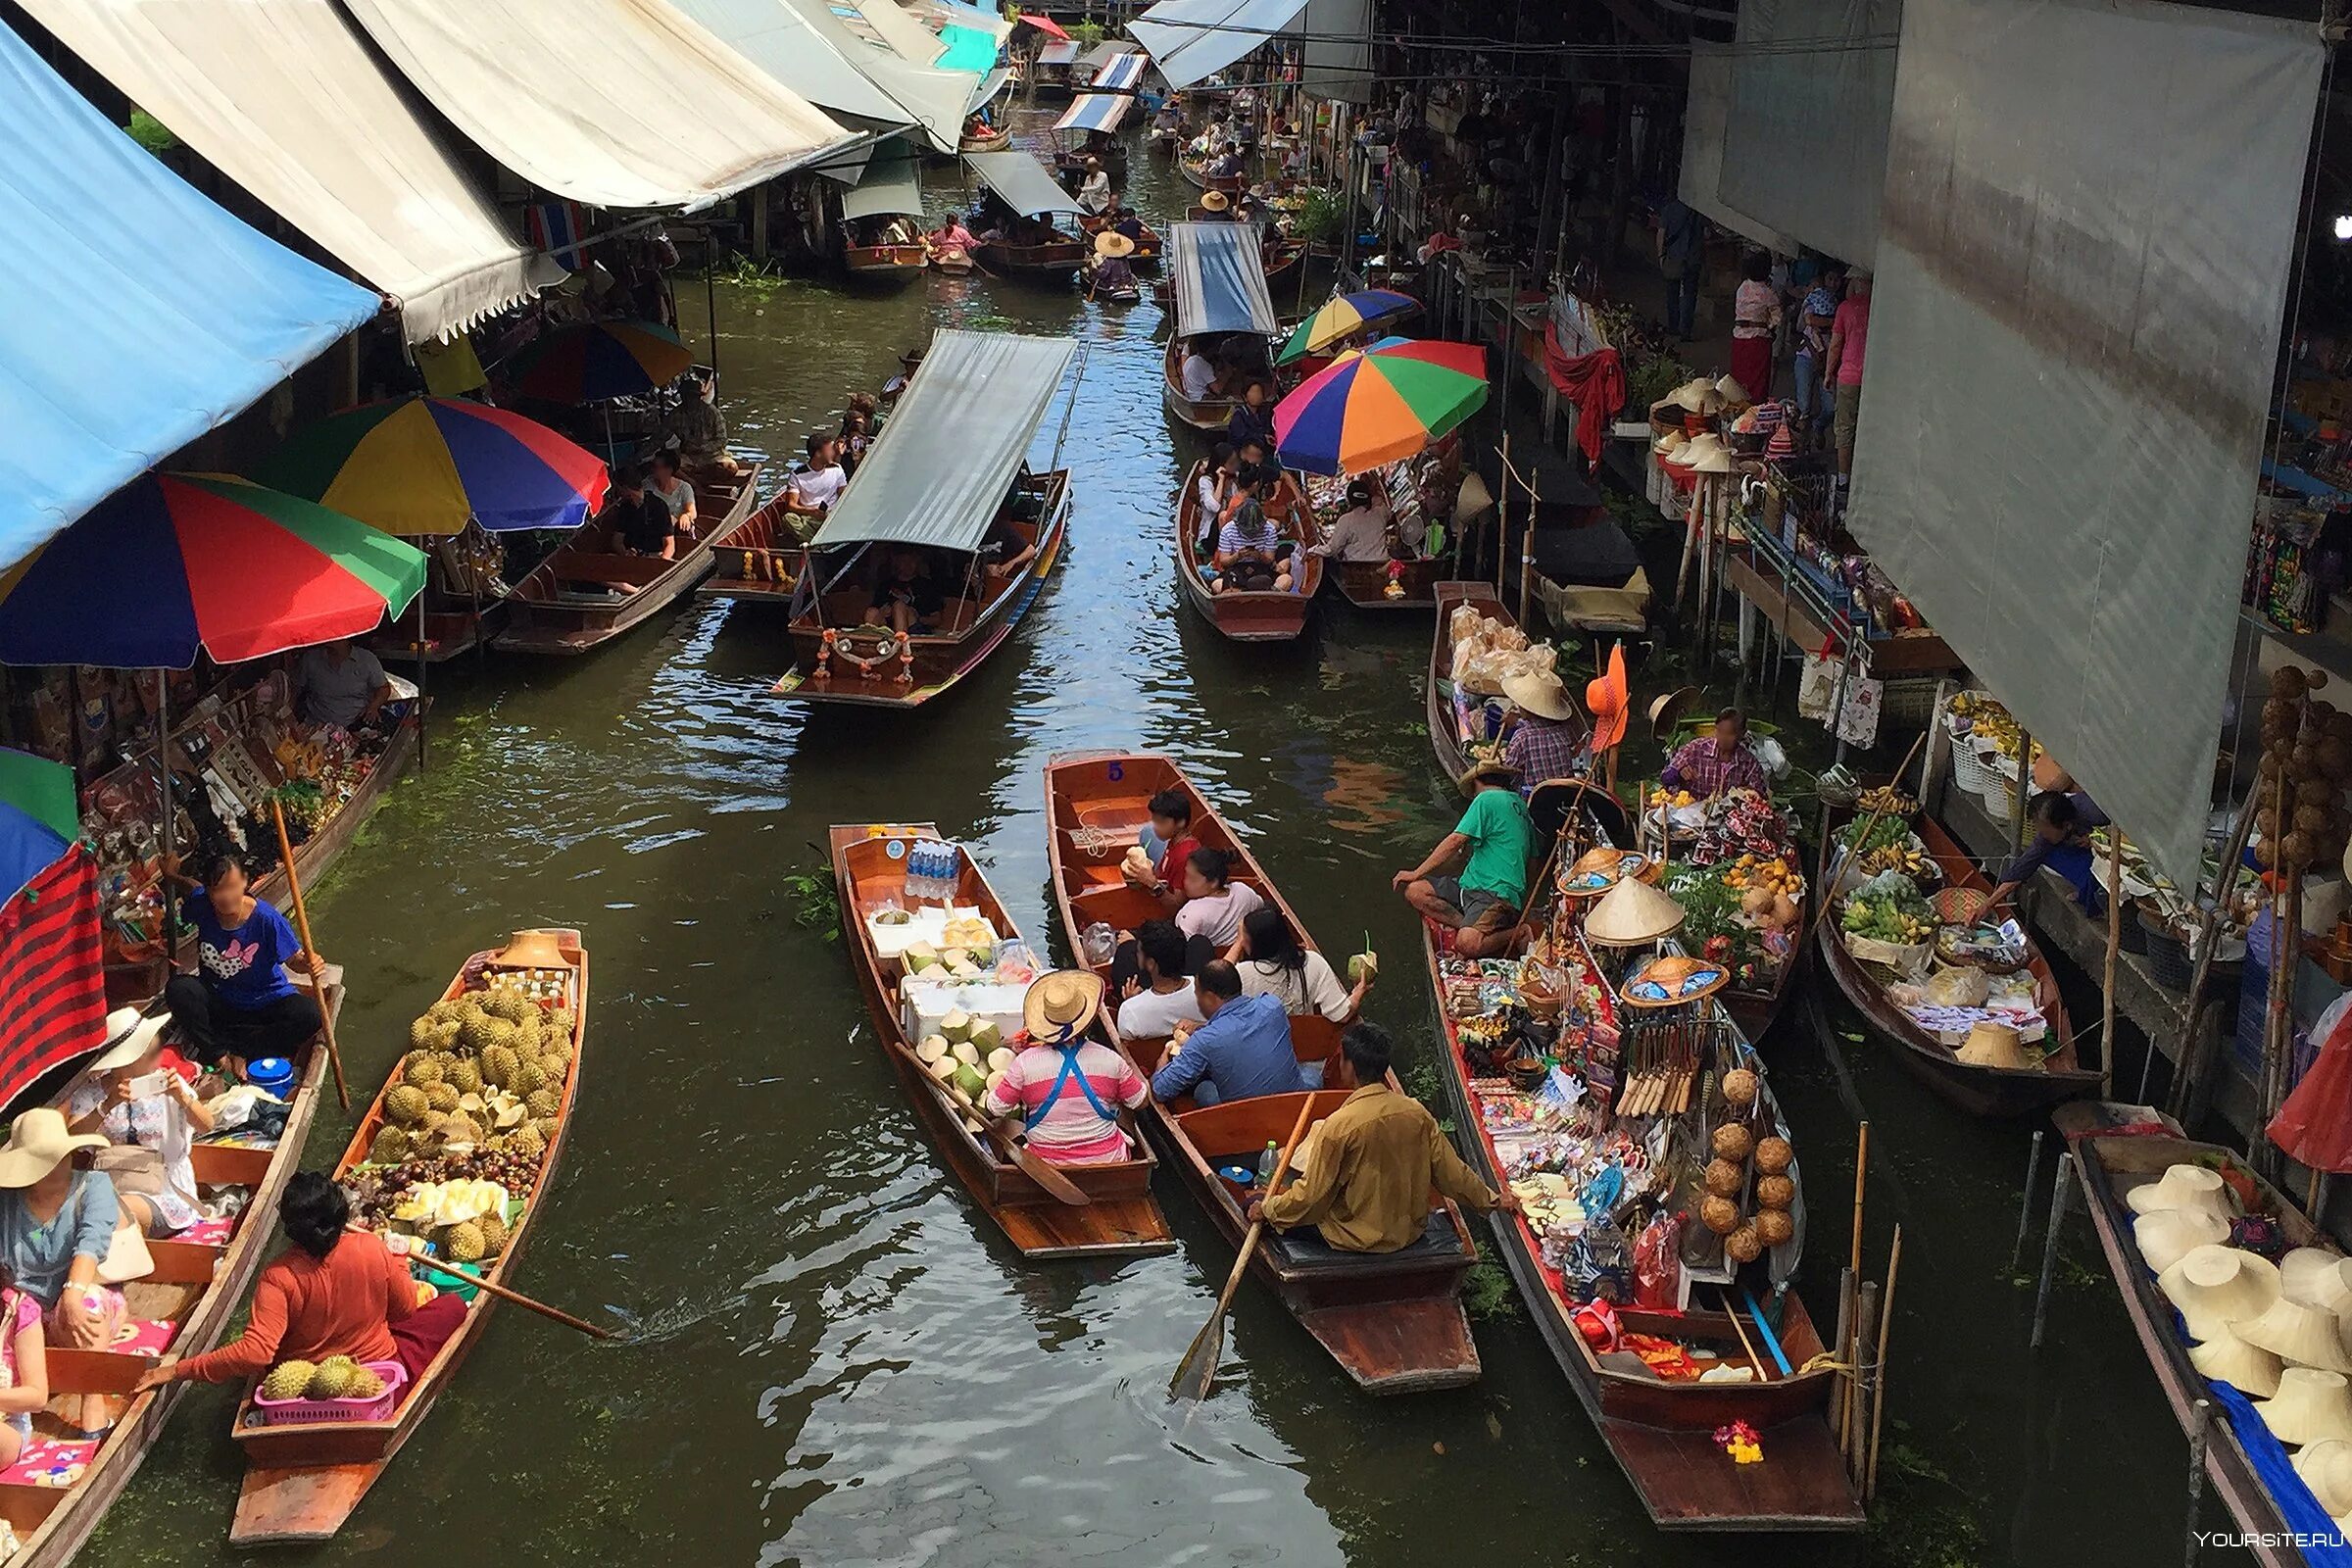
top-left (101, 113), bottom-right (2221, 1568)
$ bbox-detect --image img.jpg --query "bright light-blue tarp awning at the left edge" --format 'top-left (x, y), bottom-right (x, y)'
top-left (0, 25), bottom-right (381, 566)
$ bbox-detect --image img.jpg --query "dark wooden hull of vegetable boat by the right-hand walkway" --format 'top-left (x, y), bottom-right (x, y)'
top-left (1813, 815), bottom-right (2098, 1116)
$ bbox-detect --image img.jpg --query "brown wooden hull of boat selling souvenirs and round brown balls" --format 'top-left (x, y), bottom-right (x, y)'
top-left (1421, 921), bottom-right (1865, 1531)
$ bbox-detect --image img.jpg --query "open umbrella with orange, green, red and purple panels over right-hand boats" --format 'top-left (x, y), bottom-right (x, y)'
top-left (1275, 338), bottom-right (1487, 472)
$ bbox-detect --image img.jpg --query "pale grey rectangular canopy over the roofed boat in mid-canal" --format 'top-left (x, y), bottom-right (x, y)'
top-left (811, 331), bottom-right (1077, 550)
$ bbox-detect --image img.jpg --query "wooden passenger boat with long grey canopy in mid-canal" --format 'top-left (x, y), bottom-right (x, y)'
top-left (776, 331), bottom-right (1075, 708)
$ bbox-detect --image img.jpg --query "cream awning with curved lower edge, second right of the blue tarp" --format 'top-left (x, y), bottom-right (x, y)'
top-left (343, 0), bottom-right (849, 209)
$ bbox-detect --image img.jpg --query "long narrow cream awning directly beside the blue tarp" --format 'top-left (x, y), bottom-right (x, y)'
top-left (25, 0), bottom-right (543, 343)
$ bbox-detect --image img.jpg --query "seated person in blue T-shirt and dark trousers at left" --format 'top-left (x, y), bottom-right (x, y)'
top-left (163, 854), bottom-right (324, 1079)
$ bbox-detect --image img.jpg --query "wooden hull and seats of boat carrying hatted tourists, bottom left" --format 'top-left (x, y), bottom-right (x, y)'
top-left (0, 1001), bottom-right (343, 1568)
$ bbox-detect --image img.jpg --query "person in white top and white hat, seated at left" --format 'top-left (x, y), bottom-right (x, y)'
top-left (66, 1006), bottom-right (212, 1237)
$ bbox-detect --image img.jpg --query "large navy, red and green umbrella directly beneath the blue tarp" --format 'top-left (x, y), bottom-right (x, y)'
top-left (0, 472), bottom-right (425, 670)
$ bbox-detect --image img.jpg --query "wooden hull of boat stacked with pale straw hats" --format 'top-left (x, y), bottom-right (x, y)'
top-left (2056, 1101), bottom-right (2305, 1568)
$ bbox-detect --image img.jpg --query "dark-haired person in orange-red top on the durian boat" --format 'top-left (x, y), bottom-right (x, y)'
top-left (134, 1171), bottom-right (466, 1394)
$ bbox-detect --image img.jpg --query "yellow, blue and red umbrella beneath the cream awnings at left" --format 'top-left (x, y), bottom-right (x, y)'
top-left (254, 397), bottom-right (607, 536)
